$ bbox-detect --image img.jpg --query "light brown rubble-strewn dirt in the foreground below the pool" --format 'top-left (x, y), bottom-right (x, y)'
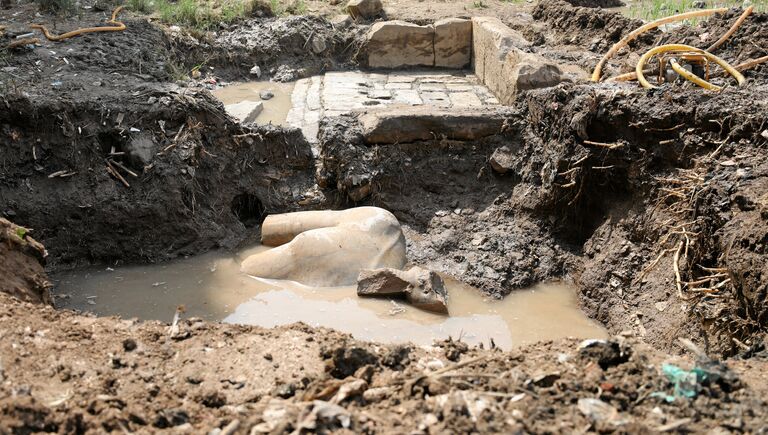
top-left (0, 294), bottom-right (768, 434)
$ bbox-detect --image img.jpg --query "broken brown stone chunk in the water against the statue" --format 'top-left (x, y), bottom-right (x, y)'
top-left (357, 266), bottom-right (448, 314)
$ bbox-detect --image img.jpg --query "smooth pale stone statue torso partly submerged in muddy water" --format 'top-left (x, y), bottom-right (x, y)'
top-left (241, 207), bottom-right (406, 287)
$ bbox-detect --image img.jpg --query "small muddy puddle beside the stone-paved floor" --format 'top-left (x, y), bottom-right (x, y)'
top-left (212, 82), bottom-right (295, 125)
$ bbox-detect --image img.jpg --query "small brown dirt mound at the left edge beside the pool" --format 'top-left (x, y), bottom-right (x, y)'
top-left (0, 218), bottom-right (52, 304)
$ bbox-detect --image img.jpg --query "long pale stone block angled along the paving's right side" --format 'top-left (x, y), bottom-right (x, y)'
top-left (472, 17), bottom-right (563, 105)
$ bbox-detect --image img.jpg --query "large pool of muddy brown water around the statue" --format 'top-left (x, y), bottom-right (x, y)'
top-left (54, 247), bottom-right (606, 349)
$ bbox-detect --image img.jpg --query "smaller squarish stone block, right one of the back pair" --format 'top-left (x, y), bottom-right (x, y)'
top-left (435, 18), bottom-right (472, 68)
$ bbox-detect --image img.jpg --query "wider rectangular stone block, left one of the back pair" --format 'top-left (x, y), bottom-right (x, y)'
top-left (367, 21), bottom-right (435, 68)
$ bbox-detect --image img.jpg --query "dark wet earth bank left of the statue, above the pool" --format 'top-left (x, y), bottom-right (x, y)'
top-left (0, 86), bottom-right (313, 267)
